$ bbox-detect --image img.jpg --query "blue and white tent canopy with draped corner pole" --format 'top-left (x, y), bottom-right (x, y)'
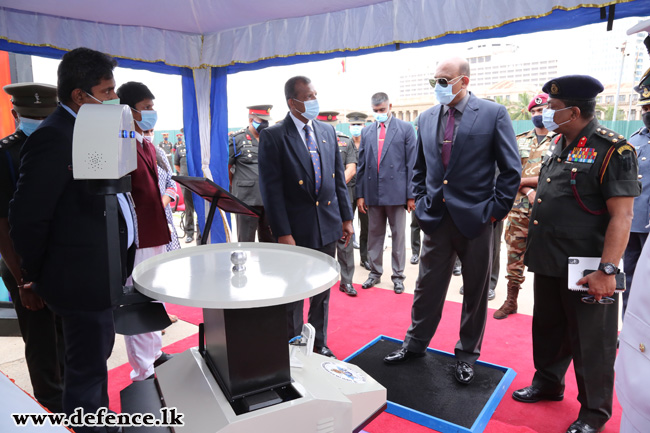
top-left (0, 0), bottom-right (650, 242)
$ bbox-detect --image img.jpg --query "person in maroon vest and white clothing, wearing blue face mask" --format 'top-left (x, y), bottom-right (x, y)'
top-left (117, 81), bottom-right (172, 381)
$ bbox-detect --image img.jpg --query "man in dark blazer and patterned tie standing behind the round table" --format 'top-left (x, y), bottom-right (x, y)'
top-left (259, 76), bottom-right (353, 357)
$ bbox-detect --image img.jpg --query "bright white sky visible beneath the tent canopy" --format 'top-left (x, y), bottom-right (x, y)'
top-left (32, 18), bottom-right (643, 130)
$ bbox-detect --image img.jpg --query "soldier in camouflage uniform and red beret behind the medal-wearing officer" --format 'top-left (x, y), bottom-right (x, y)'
top-left (493, 93), bottom-right (555, 319)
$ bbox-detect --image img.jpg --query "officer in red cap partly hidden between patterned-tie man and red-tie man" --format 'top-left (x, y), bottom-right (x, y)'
top-left (316, 111), bottom-right (357, 296)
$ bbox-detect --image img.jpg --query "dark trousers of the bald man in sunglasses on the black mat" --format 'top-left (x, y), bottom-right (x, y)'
top-left (404, 214), bottom-right (492, 364)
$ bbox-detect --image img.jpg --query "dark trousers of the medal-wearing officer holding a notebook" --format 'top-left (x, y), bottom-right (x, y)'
top-left (533, 274), bottom-right (618, 428)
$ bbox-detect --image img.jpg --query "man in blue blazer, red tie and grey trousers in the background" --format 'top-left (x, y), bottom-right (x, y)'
top-left (357, 92), bottom-right (415, 294)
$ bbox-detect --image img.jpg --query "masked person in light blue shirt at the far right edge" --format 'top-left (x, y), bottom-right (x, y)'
top-left (622, 69), bottom-right (650, 316)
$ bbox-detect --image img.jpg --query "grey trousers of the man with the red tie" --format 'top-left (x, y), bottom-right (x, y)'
top-left (368, 205), bottom-right (406, 283)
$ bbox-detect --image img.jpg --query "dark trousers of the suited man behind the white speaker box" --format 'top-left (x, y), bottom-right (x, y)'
top-left (50, 305), bottom-right (115, 433)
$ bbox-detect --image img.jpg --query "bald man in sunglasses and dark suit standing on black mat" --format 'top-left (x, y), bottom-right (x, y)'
top-left (384, 58), bottom-right (521, 384)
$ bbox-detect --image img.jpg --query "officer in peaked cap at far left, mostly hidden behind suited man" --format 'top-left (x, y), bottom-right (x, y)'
top-left (0, 83), bottom-right (64, 412)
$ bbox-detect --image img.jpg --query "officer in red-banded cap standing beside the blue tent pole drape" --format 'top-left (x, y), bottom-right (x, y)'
top-left (228, 105), bottom-right (274, 242)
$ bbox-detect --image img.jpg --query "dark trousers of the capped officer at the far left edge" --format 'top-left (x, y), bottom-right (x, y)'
top-left (0, 259), bottom-right (64, 412)
